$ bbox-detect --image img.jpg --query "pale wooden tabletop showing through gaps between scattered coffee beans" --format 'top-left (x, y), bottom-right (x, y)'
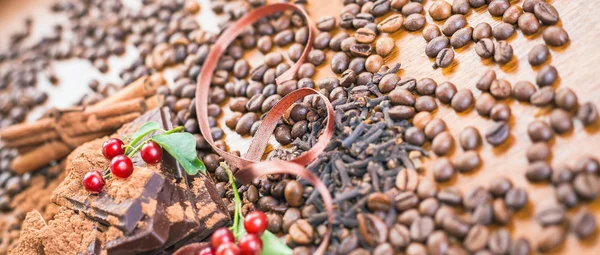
top-left (0, 0), bottom-right (600, 254)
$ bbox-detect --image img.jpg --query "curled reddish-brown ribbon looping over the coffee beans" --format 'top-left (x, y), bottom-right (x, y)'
top-left (196, 3), bottom-right (334, 255)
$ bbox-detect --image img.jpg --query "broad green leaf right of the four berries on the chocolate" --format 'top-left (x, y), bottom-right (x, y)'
top-left (152, 133), bottom-right (206, 175)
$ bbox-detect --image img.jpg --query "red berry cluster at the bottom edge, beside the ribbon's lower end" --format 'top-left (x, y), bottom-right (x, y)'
top-left (198, 211), bottom-right (268, 255)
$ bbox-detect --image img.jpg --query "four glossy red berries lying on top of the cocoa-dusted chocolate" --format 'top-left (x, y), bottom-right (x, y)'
top-left (83, 138), bottom-right (162, 193)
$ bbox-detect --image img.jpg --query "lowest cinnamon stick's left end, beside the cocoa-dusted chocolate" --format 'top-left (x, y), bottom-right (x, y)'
top-left (10, 141), bottom-right (71, 174)
